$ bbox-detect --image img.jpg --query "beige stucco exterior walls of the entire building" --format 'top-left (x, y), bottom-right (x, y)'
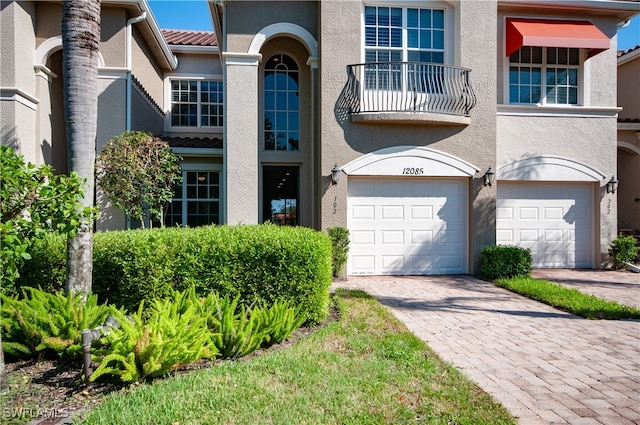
top-left (0, 0), bottom-right (640, 273)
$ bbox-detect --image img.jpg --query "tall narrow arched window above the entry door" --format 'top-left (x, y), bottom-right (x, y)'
top-left (264, 53), bottom-right (300, 151)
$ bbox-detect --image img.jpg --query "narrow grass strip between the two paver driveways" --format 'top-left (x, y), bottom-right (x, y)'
top-left (494, 277), bottom-right (640, 320)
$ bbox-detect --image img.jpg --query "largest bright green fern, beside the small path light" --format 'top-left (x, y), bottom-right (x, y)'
top-left (90, 291), bottom-right (218, 382)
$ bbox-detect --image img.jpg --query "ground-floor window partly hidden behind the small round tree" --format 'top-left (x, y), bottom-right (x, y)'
top-left (165, 170), bottom-right (220, 227)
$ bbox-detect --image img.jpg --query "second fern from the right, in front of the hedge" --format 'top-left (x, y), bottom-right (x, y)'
top-left (203, 293), bottom-right (265, 359)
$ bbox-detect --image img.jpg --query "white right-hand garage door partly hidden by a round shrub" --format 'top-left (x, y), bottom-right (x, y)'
top-left (496, 181), bottom-right (594, 268)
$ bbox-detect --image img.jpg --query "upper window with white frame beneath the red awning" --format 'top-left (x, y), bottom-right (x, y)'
top-left (509, 46), bottom-right (581, 105)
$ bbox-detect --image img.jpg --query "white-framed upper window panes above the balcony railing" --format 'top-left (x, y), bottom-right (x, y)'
top-left (364, 6), bottom-right (445, 63)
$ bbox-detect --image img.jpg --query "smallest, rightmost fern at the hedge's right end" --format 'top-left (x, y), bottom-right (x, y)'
top-left (251, 300), bottom-right (307, 348)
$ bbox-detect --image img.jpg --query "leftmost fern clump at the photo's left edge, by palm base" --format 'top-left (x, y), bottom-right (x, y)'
top-left (0, 287), bottom-right (116, 357)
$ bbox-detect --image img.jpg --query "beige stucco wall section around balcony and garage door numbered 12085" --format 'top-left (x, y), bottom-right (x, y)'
top-left (320, 0), bottom-right (497, 268)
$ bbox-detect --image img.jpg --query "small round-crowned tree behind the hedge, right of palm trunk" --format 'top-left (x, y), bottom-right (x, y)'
top-left (97, 131), bottom-right (182, 228)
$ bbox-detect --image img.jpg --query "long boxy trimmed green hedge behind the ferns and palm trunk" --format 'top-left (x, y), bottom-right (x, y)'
top-left (18, 224), bottom-right (332, 323)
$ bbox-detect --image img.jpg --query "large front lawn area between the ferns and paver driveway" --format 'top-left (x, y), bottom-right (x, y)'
top-left (76, 290), bottom-right (516, 425)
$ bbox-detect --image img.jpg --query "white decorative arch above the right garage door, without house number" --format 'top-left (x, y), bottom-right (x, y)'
top-left (496, 155), bottom-right (606, 182)
